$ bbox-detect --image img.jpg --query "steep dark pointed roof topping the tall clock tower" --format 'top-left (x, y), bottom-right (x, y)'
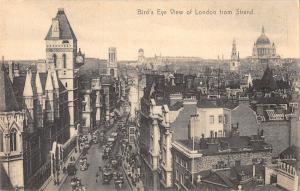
top-left (45, 9), bottom-right (77, 40)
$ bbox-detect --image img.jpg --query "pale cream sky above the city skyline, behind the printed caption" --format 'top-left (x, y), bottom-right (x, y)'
top-left (0, 0), bottom-right (300, 60)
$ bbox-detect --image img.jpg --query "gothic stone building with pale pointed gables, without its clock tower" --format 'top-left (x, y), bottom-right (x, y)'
top-left (0, 63), bottom-right (70, 189)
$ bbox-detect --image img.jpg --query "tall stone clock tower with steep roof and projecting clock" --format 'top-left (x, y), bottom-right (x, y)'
top-left (45, 8), bottom-right (84, 136)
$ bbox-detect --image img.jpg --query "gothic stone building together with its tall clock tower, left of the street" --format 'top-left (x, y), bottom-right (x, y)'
top-left (0, 9), bottom-right (84, 189)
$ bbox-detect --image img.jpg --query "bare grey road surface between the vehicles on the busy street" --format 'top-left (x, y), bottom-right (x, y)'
top-left (60, 115), bottom-right (130, 191)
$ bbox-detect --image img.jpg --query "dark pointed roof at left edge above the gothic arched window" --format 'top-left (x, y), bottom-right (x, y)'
top-left (0, 65), bottom-right (20, 112)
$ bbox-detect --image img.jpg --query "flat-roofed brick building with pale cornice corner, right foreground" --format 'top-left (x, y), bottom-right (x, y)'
top-left (172, 134), bottom-right (272, 190)
